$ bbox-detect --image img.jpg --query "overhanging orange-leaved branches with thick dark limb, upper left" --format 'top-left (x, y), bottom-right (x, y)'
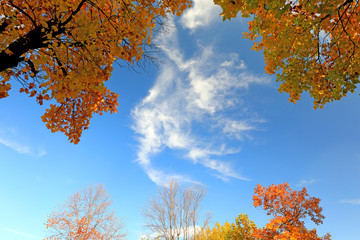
top-left (0, 0), bottom-right (191, 143)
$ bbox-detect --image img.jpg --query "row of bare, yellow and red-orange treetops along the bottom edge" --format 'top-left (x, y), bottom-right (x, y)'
top-left (45, 181), bottom-right (331, 240)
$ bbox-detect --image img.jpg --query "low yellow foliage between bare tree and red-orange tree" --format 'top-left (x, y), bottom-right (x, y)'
top-left (196, 214), bottom-right (256, 240)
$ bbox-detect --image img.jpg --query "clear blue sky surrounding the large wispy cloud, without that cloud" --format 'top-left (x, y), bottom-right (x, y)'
top-left (0, 1), bottom-right (360, 240)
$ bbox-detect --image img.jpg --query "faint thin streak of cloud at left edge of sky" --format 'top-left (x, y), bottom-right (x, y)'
top-left (0, 128), bottom-right (46, 157)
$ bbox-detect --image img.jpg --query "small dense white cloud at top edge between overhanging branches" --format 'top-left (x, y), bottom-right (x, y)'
top-left (180, 0), bottom-right (221, 31)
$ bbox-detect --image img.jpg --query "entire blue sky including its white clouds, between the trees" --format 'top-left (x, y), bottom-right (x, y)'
top-left (0, 0), bottom-right (360, 240)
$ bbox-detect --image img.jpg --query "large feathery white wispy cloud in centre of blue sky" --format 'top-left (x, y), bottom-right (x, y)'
top-left (132, 20), bottom-right (269, 185)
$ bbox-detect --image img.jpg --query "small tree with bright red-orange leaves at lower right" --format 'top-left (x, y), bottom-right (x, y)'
top-left (253, 182), bottom-right (330, 240)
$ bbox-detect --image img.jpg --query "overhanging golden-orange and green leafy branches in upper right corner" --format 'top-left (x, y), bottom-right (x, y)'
top-left (214, 0), bottom-right (360, 109)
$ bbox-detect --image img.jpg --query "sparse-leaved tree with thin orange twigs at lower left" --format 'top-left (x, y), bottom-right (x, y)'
top-left (45, 185), bottom-right (125, 240)
